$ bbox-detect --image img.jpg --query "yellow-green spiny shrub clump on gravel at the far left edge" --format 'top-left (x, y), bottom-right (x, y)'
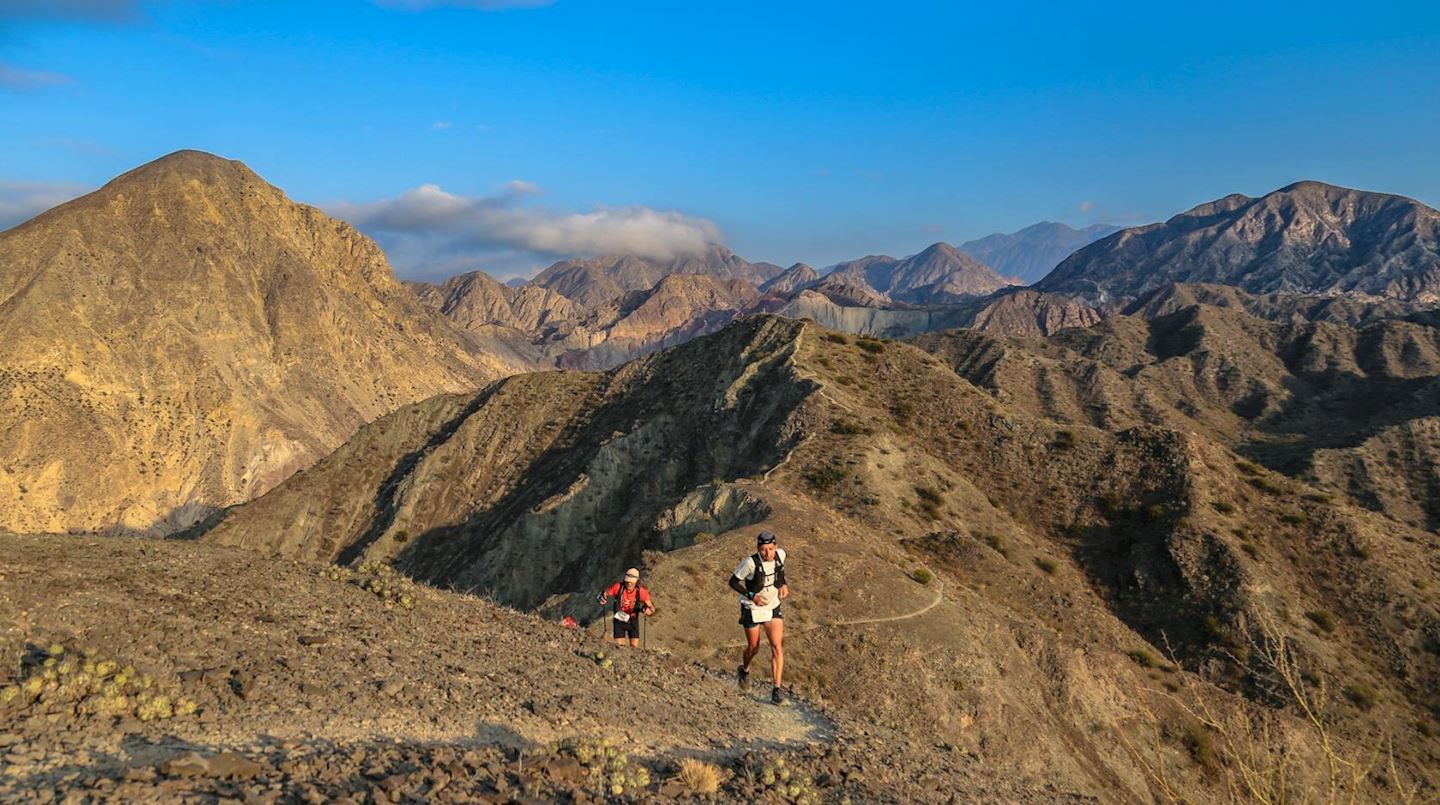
top-left (0, 644), bottom-right (199, 721)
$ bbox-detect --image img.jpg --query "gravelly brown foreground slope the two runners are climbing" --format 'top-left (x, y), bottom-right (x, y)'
top-left (0, 536), bottom-right (1088, 802)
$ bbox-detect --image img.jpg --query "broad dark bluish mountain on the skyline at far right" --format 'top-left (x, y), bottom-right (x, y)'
top-left (1037, 181), bottom-right (1440, 304)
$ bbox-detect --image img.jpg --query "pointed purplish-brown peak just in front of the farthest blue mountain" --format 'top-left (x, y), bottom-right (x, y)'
top-left (825, 243), bottom-right (1009, 304)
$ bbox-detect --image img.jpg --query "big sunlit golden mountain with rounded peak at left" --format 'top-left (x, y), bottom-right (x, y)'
top-left (0, 151), bottom-right (527, 533)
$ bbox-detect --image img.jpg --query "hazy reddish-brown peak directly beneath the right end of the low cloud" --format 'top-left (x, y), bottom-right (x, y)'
top-left (528, 245), bottom-right (783, 308)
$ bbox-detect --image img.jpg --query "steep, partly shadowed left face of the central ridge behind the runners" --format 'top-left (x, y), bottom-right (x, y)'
top-left (206, 318), bottom-right (811, 606)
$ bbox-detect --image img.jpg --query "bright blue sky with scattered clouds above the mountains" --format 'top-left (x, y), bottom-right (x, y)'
top-left (0, 0), bottom-right (1440, 276)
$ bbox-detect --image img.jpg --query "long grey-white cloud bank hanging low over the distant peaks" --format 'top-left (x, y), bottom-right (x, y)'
top-left (327, 180), bottom-right (721, 272)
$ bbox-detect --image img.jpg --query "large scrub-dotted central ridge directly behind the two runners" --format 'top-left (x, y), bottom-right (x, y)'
top-left (204, 314), bottom-right (1440, 801)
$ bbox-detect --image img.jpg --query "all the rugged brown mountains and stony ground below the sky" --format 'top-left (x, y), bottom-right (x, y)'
top-left (0, 151), bottom-right (1440, 802)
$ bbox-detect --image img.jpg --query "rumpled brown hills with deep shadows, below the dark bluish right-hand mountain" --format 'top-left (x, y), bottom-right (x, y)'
top-left (916, 287), bottom-right (1440, 530)
